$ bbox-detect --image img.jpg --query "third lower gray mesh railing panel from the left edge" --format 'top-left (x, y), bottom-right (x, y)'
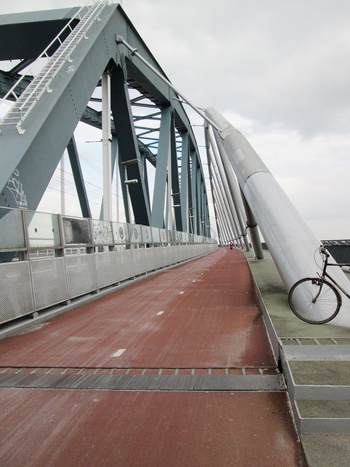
top-left (66, 254), bottom-right (97, 298)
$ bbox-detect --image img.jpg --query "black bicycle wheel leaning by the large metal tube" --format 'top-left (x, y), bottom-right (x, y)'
top-left (288, 277), bottom-right (341, 324)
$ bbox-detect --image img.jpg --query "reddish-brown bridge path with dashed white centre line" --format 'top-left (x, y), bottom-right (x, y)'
top-left (0, 248), bottom-right (303, 466)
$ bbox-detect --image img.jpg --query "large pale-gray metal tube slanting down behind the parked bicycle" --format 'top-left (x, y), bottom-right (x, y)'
top-left (206, 109), bottom-right (350, 326)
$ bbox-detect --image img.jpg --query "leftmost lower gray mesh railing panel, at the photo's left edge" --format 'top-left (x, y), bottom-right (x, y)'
top-left (0, 261), bottom-right (34, 323)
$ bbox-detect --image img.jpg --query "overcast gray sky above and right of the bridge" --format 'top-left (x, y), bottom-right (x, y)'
top-left (0, 0), bottom-right (350, 239)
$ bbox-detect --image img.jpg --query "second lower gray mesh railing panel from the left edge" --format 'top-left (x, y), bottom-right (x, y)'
top-left (31, 258), bottom-right (69, 310)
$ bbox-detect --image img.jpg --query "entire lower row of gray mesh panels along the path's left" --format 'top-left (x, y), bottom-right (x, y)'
top-left (0, 244), bottom-right (217, 323)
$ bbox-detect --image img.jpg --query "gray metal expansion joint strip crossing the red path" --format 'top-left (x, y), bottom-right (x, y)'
top-left (0, 368), bottom-right (286, 391)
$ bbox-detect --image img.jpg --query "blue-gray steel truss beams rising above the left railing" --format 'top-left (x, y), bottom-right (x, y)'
top-left (0, 1), bottom-right (210, 235)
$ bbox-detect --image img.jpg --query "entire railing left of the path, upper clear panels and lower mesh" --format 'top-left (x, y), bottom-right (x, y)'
top-left (0, 208), bottom-right (217, 324)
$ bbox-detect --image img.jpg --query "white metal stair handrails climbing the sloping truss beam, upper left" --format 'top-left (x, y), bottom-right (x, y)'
top-left (0, 0), bottom-right (109, 134)
